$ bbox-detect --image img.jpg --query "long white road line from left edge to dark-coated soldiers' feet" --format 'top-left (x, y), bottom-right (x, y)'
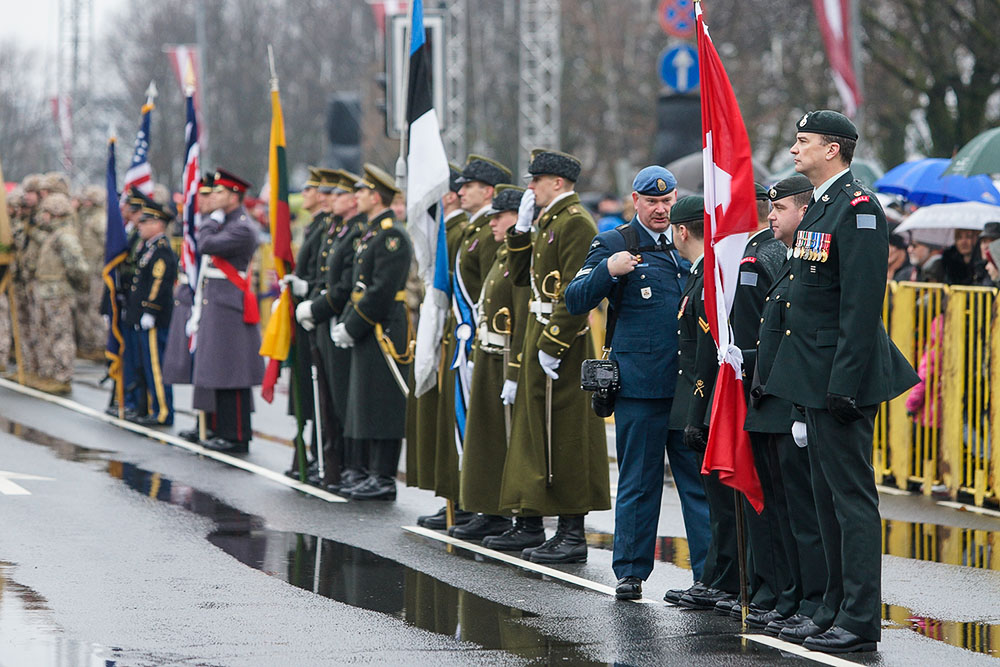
top-left (0, 378), bottom-right (347, 503)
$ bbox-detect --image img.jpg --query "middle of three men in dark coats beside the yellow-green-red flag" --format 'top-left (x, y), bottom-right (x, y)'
top-left (310, 170), bottom-right (369, 493)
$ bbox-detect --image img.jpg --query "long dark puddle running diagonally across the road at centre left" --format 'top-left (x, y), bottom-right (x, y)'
top-left (108, 461), bottom-right (603, 664)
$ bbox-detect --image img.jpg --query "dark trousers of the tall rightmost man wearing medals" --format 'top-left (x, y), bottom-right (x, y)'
top-left (806, 406), bottom-right (882, 641)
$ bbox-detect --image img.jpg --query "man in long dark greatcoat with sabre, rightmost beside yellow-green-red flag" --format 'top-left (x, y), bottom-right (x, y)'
top-left (330, 164), bottom-right (413, 500)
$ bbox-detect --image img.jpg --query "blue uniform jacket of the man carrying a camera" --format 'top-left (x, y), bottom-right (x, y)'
top-left (565, 218), bottom-right (691, 398)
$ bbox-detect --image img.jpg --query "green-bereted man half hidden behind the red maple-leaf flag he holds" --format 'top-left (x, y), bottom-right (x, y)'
top-left (664, 195), bottom-right (739, 609)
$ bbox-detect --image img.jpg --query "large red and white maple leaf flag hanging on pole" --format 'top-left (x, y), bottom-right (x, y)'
top-left (695, 3), bottom-right (764, 512)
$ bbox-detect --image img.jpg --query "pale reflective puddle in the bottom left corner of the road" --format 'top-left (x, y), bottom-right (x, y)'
top-left (0, 563), bottom-right (116, 667)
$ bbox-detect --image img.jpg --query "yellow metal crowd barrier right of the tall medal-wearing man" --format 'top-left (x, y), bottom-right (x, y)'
top-left (873, 282), bottom-right (1000, 505)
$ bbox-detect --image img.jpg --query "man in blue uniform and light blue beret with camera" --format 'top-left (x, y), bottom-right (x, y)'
top-left (566, 166), bottom-right (709, 599)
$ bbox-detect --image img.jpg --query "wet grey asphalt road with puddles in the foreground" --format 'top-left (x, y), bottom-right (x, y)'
top-left (0, 368), bottom-right (1000, 666)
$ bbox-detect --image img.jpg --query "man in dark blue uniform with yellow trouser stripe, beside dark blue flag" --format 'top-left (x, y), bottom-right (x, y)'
top-left (125, 202), bottom-right (177, 426)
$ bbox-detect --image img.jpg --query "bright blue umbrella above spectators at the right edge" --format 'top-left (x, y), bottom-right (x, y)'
top-left (875, 158), bottom-right (1000, 206)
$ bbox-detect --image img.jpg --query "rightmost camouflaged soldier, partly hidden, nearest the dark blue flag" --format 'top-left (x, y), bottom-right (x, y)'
top-left (74, 185), bottom-right (107, 361)
